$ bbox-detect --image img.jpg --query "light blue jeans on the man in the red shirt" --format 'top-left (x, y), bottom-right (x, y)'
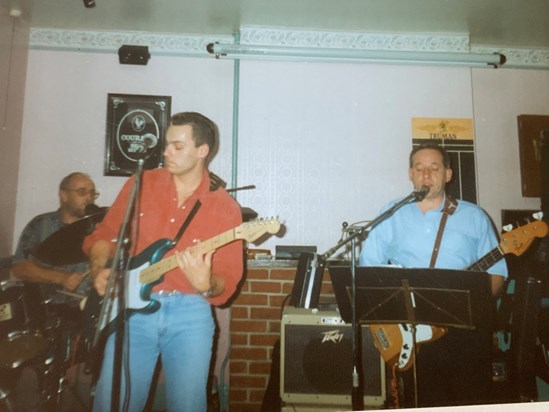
top-left (93, 294), bottom-right (214, 412)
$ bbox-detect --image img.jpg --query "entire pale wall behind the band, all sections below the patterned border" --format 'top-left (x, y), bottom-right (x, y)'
top-left (10, 50), bottom-right (549, 252)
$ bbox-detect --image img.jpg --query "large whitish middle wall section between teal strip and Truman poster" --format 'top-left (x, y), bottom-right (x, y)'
top-left (239, 62), bottom-right (480, 253)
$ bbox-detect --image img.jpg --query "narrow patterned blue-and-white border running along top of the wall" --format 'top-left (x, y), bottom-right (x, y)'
top-left (30, 26), bottom-right (549, 69)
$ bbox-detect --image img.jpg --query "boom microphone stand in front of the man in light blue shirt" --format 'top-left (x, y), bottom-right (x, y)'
top-left (321, 186), bottom-right (429, 411)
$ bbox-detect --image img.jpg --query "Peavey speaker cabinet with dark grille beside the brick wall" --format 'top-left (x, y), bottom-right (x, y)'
top-left (280, 307), bottom-right (386, 410)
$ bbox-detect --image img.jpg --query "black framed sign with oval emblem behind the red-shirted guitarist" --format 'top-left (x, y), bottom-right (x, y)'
top-left (104, 93), bottom-right (172, 176)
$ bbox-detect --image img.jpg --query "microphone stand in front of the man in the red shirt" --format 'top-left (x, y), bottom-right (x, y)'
top-left (94, 159), bottom-right (144, 412)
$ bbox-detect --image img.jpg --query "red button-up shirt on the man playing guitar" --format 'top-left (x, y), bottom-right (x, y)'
top-left (83, 169), bottom-right (243, 305)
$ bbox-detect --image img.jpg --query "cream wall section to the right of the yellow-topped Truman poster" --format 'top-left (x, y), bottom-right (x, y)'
top-left (473, 70), bottom-right (549, 216)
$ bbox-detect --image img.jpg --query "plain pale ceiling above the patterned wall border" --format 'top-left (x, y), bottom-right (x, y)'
top-left (0, 0), bottom-right (549, 49)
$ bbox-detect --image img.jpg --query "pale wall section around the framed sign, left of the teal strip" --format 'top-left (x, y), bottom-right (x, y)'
top-left (14, 50), bottom-right (233, 247)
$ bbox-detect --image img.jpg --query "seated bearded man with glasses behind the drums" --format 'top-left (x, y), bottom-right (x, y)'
top-left (11, 172), bottom-right (99, 411)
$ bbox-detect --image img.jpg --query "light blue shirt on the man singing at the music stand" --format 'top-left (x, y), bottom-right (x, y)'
top-left (359, 199), bottom-right (507, 277)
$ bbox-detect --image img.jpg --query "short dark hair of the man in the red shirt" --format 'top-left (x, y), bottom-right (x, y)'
top-left (170, 112), bottom-right (219, 164)
